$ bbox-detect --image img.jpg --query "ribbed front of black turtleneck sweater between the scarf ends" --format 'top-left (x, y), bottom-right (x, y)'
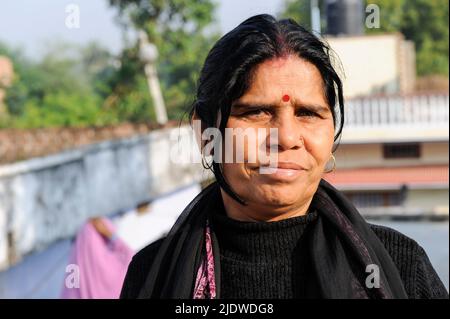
top-left (212, 212), bottom-right (317, 299)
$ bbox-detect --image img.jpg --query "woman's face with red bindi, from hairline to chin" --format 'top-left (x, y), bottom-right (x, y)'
top-left (223, 55), bottom-right (334, 217)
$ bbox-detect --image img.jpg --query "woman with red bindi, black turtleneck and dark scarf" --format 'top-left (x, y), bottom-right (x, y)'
top-left (121, 15), bottom-right (448, 298)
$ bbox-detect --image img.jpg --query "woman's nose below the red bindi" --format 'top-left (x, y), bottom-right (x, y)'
top-left (272, 110), bottom-right (304, 152)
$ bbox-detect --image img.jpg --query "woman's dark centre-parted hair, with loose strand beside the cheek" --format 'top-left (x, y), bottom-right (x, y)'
top-left (189, 14), bottom-right (344, 204)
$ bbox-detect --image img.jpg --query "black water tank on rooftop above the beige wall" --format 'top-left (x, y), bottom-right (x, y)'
top-left (326, 0), bottom-right (364, 35)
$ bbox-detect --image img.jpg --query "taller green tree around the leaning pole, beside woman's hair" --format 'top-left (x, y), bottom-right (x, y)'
top-left (106, 0), bottom-right (218, 120)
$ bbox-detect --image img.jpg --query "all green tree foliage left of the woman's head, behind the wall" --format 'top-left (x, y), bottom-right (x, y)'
top-left (0, 0), bottom-right (218, 128)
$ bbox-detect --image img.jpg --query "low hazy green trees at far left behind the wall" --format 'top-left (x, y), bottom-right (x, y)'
top-left (0, 43), bottom-right (112, 128)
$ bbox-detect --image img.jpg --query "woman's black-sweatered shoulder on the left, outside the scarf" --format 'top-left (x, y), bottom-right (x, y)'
top-left (120, 238), bottom-right (164, 299)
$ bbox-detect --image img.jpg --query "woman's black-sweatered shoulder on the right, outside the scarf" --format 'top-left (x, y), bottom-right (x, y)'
top-left (369, 224), bottom-right (448, 299)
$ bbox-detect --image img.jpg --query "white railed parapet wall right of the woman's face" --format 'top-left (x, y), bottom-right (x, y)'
top-left (341, 93), bottom-right (449, 144)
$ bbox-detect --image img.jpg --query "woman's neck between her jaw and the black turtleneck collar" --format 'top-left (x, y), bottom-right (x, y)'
top-left (220, 189), bottom-right (312, 222)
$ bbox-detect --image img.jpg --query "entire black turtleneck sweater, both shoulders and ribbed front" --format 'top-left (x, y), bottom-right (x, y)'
top-left (121, 212), bottom-right (448, 299)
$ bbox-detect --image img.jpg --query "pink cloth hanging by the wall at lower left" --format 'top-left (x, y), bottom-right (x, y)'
top-left (61, 218), bottom-right (134, 299)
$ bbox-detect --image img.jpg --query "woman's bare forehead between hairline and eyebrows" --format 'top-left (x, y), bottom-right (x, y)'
top-left (239, 55), bottom-right (326, 103)
